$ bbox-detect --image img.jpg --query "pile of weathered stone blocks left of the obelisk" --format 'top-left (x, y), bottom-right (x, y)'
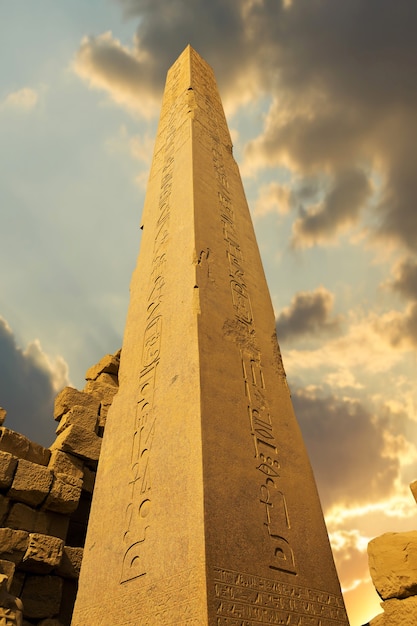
top-left (0, 351), bottom-right (120, 626)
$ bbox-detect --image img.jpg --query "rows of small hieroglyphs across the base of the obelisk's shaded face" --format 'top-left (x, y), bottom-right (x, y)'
top-left (214, 568), bottom-right (348, 626)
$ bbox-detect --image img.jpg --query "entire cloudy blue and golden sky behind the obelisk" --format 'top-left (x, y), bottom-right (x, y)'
top-left (0, 0), bottom-right (417, 626)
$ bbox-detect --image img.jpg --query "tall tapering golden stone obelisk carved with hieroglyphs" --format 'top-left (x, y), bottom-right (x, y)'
top-left (72, 46), bottom-right (348, 626)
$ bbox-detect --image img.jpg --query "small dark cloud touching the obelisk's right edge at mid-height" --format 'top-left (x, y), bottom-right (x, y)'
top-left (276, 287), bottom-right (340, 341)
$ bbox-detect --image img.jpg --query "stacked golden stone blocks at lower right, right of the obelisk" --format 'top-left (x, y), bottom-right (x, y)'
top-left (368, 481), bottom-right (417, 626)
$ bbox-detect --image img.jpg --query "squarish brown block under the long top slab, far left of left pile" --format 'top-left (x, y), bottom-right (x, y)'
top-left (8, 459), bottom-right (53, 506)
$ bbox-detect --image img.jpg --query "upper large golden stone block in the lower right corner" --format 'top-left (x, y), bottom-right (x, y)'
top-left (368, 531), bottom-right (417, 600)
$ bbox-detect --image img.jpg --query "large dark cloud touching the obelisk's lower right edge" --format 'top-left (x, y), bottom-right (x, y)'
top-left (293, 390), bottom-right (399, 509)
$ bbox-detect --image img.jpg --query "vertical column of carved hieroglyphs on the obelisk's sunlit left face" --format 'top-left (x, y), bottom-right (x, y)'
top-left (121, 59), bottom-right (180, 583)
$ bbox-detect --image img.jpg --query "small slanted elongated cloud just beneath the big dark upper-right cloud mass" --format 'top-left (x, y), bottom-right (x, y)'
top-left (292, 169), bottom-right (371, 248)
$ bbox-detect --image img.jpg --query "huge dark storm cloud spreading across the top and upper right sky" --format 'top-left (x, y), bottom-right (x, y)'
top-left (77, 0), bottom-right (417, 249)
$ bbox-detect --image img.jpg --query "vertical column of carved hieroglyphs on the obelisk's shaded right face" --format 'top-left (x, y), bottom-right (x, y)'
top-left (191, 53), bottom-right (296, 574)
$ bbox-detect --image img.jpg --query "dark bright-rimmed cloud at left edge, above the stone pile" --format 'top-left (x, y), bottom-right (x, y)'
top-left (0, 318), bottom-right (68, 446)
